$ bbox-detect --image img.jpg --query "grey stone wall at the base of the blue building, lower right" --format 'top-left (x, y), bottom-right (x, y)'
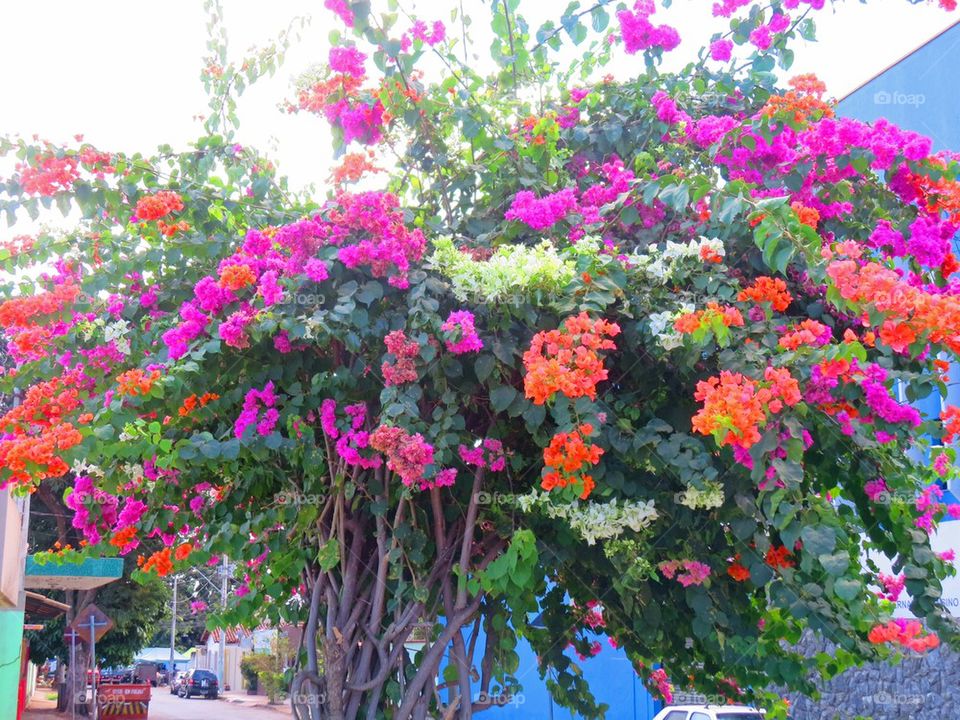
top-left (790, 637), bottom-right (960, 720)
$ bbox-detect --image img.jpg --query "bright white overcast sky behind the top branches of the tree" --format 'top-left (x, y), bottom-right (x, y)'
top-left (0, 0), bottom-right (960, 187)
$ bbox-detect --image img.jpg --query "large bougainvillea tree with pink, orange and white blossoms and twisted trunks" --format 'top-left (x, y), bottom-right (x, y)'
top-left (0, 0), bottom-right (960, 719)
